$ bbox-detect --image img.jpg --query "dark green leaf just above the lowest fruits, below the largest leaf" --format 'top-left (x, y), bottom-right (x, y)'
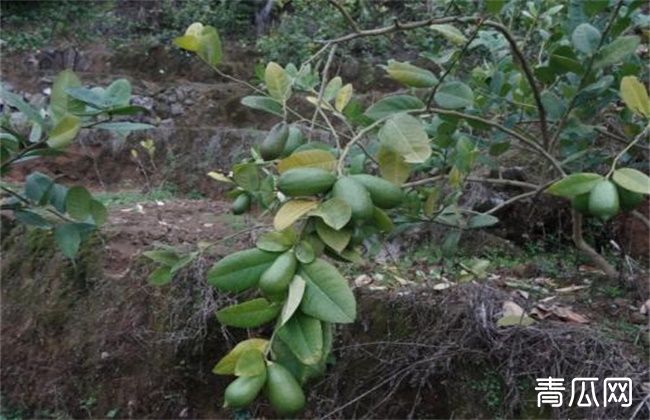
top-left (276, 312), bottom-right (323, 365)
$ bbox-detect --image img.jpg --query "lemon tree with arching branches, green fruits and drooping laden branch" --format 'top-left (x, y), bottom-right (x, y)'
top-left (170, 0), bottom-right (650, 415)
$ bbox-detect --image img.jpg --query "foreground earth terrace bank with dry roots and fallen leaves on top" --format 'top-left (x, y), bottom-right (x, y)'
top-left (1, 200), bottom-right (648, 418)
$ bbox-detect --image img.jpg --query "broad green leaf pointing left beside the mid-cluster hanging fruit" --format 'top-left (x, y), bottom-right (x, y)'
top-left (208, 248), bottom-right (278, 293)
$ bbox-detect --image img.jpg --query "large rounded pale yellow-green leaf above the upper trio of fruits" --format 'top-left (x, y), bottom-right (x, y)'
top-left (378, 114), bottom-right (432, 163)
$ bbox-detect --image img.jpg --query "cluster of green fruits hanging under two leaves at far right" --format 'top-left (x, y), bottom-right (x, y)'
top-left (571, 179), bottom-right (645, 220)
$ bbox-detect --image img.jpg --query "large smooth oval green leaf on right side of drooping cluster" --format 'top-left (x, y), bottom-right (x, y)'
top-left (299, 259), bottom-right (357, 323)
